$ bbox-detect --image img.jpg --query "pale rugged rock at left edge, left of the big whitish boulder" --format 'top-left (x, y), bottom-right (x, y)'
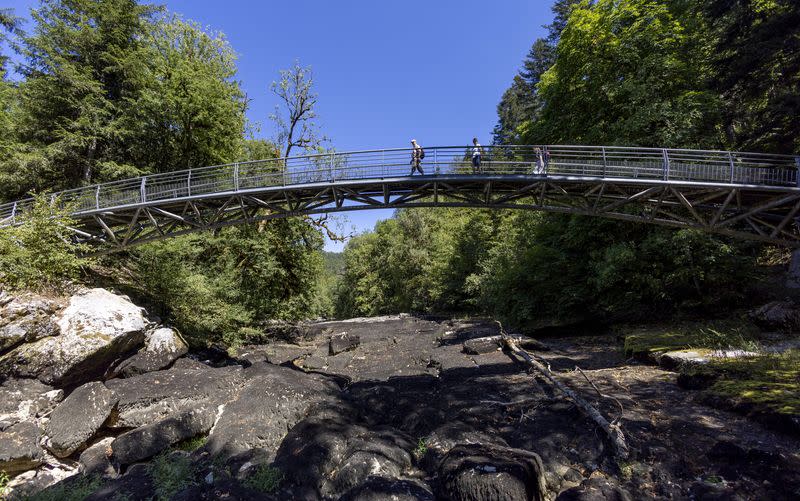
top-left (0, 294), bottom-right (60, 353)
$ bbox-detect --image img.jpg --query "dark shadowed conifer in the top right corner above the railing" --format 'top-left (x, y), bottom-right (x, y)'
top-left (701, 0), bottom-right (800, 153)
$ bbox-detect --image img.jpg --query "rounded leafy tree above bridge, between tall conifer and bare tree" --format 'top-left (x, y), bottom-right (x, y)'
top-left (125, 14), bottom-right (246, 172)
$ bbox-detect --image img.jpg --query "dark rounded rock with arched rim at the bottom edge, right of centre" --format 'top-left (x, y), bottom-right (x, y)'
top-left (438, 444), bottom-right (547, 501)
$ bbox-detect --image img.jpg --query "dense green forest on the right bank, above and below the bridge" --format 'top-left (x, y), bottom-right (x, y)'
top-left (337, 0), bottom-right (800, 327)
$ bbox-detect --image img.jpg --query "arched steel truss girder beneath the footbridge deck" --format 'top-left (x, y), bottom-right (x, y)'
top-left (65, 176), bottom-right (800, 254)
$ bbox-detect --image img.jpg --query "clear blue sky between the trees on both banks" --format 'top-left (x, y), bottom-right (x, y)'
top-left (4, 0), bottom-right (552, 250)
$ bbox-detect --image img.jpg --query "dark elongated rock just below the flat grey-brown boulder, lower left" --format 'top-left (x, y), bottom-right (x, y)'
top-left (111, 406), bottom-right (217, 465)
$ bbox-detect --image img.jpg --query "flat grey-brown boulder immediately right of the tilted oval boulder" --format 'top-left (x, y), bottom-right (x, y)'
top-left (106, 364), bottom-right (245, 428)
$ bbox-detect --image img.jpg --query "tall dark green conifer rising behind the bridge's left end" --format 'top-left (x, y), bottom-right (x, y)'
top-left (15, 0), bottom-right (154, 195)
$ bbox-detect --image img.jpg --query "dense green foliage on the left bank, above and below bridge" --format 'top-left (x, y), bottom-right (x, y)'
top-left (0, 0), bottom-right (331, 344)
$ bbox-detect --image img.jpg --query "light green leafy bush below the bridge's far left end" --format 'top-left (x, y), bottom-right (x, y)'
top-left (0, 195), bottom-right (85, 291)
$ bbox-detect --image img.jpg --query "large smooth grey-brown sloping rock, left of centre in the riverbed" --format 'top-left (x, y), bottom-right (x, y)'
top-left (206, 362), bottom-right (339, 457)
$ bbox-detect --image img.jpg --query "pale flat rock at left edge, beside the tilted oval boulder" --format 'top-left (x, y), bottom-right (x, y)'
top-left (0, 379), bottom-right (64, 430)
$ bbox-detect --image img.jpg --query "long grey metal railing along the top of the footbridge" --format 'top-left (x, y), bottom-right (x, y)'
top-left (0, 145), bottom-right (800, 226)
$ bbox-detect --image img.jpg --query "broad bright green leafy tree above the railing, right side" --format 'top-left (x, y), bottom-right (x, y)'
top-left (524, 0), bottom-right (721, 147)
